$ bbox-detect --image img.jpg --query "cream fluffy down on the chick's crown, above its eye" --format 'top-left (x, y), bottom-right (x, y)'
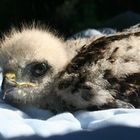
top-left (2, 28), bottom-right (68, 70)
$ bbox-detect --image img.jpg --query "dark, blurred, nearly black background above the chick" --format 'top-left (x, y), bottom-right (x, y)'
top-left (0, 0), bottom-right (140, 36)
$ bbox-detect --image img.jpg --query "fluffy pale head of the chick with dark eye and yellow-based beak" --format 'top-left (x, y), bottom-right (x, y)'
top-left (0, 29), bottom-right (68, 110)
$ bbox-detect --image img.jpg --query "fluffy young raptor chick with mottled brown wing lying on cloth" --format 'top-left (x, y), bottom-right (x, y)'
top-left (0, 26), bottom-right (140, 112)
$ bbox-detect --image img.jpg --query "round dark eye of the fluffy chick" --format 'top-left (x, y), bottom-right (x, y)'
top-left (31, 63), bottom-right (49, 77)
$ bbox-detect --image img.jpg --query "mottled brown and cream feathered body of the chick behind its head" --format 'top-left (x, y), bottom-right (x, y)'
top-left (52, 24), bottom-right (140, 110)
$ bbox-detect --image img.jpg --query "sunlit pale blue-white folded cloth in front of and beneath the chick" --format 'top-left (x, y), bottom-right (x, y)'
top-left (0, 102), bottom-right (140, 138)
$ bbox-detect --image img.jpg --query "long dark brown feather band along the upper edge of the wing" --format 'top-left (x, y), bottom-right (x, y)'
top-left (66, 28), bottom-right (140, 73)
